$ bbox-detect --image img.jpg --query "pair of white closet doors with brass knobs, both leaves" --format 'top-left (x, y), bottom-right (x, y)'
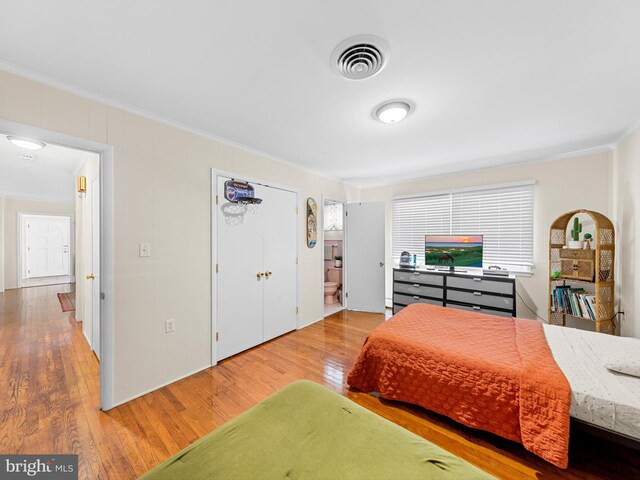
top-left (213, 176), bottom-right (297, 360)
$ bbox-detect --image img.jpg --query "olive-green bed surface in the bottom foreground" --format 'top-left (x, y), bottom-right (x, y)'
top-left (141, 380), bottom-right (493, 480)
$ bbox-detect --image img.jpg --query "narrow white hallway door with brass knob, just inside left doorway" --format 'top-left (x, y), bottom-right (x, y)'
top-left (90, 178), bottom-right (100, 358)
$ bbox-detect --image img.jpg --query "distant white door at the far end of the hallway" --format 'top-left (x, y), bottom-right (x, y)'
top-left (23, 215), bottom-right (71, 278)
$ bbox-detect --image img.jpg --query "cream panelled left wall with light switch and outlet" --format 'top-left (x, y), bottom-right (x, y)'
top-left (0, 67), bottom-right (357, 403)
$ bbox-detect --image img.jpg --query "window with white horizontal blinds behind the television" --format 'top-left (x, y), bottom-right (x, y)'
top-left (392, 182), bottom-right (534, 272)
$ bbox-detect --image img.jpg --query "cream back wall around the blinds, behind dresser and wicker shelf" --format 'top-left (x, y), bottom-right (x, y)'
top-left (360, 152), bottom-right (611, 329)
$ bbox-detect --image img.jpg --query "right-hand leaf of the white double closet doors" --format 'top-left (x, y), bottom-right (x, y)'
top-left (258, 188), bottom-right (297, 342)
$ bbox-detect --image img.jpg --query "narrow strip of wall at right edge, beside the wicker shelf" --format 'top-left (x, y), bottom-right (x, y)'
top-left (613, 129), bottom-right (640, 338)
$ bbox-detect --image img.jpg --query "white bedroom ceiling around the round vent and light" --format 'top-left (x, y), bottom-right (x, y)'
top-left (0, 0), bottom-right (640, 185)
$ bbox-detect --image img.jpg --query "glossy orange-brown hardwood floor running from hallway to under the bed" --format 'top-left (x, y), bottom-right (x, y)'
top-left (0, 285), bottom-right (640, 479)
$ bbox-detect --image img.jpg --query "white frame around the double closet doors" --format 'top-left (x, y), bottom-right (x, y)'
top-left (209, 168), bottom-right (304, 366)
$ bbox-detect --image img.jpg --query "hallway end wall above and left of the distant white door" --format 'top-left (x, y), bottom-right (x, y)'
top-left (4, 197), bottom-right (75, 289)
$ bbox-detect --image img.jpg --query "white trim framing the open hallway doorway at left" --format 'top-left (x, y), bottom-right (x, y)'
top-left (0, 119), bottom-right (115, 410)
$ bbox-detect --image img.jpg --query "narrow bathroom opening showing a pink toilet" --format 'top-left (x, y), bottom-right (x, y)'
top-left (322, 197), bottom-right (347, 317)
